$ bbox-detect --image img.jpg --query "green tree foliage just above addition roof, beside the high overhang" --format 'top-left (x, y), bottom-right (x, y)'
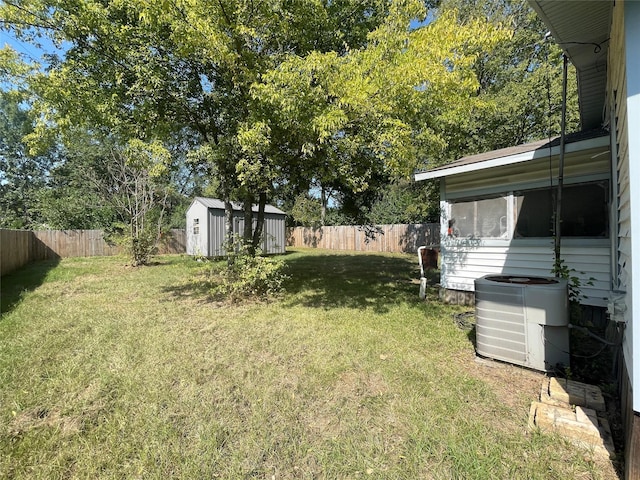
top-left (440, 0), bottom-right (579, 162)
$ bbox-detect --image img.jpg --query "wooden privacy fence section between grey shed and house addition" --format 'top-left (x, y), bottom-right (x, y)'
top-left (287, 223), bottom-right (440, 253)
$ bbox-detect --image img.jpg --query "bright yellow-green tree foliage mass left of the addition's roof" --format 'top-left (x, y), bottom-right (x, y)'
top-left (249, 7), bottom-right (509, 221)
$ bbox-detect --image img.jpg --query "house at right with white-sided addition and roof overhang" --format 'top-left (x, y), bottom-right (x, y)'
top-left (416, 0), bottom-right (640, 479)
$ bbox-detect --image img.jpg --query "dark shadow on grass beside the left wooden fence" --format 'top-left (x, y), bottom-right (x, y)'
top-left (0, 258), bottom-right (60, 315)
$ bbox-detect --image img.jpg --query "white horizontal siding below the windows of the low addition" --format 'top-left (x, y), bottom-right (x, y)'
top-left (441, 239), bottom-right (611, 306)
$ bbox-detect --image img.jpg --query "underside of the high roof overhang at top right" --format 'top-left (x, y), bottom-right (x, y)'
top-left (529, 0), bottom-right (614, 130)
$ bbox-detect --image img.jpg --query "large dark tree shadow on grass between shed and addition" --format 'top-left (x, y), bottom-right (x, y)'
top-left (285, 254), bottom-right (435, 313)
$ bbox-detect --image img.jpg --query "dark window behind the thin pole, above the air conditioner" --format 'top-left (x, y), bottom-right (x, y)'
top-left (513, 182), bottom-right (609, 238)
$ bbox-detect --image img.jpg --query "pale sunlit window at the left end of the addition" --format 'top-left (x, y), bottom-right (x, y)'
top-left (447, 197), bottom-right (509, 238)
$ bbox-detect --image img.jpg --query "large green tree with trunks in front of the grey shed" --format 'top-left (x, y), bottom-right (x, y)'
top-left (0, 0), bottom-right (400, 253)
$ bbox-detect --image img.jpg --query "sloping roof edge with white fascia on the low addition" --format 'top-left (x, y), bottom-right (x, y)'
top-left (414, 129), bottom-right (610, 181)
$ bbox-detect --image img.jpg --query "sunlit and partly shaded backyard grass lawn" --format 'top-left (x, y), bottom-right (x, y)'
top-left (0, 250), bottom-right (617, 479)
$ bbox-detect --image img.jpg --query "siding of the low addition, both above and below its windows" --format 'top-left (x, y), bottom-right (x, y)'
top-left (440, 146), bottom-right (615, 307)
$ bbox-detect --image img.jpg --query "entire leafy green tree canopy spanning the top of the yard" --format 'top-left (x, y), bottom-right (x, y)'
top-left (0, 0), bottom-right (558, 236)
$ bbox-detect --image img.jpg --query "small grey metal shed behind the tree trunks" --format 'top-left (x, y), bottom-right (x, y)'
top-left (187, 197), bottom-right (286, 257)
